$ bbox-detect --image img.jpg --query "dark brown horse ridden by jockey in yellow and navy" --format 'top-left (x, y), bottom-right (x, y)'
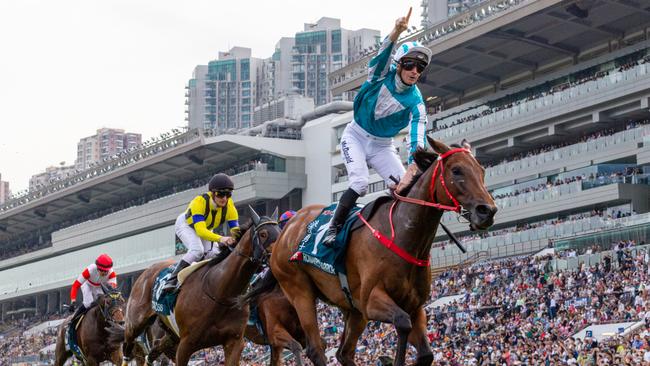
top-left (123, 209), bottom-right (280, 366)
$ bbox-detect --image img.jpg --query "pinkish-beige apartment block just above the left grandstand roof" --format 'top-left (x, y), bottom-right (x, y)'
top-left (75, 128), bottom-right (142, 170)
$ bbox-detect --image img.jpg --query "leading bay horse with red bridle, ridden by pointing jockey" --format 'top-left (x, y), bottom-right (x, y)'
top-left (271, 138), bottom-right (497, 366)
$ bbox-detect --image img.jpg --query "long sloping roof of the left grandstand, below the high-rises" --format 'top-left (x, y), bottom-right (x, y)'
top-left (0, 135), bottom-right (304, 240)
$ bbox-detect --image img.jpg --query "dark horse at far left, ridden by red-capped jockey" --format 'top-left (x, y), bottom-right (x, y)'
top-left (54, 285), bottom-right (126, 366)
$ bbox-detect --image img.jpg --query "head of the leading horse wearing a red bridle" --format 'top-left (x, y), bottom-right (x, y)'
top-left (413, 136), bottom-right (497, 230)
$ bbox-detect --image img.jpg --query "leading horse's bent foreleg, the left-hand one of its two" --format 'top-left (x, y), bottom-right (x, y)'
top-left (366, 287), bottom-right (413, 366)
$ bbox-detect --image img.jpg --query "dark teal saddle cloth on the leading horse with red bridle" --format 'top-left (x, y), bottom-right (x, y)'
top-left (289, 204), bottom-right (361, 275)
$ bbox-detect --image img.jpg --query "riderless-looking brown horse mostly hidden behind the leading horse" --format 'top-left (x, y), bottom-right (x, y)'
top-left (240, 270), bottom-right (306, 366)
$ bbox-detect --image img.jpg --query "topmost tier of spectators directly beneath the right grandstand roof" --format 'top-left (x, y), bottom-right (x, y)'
top-left (431, 50), bottom-right (650, 132)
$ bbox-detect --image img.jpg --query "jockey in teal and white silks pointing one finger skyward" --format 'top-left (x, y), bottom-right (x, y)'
top-left (323, 9), bottom-right (432, 246)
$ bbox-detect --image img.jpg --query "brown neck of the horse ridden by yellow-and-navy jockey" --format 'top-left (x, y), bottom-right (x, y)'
top-left (208, 234), bottom-right (257, 298)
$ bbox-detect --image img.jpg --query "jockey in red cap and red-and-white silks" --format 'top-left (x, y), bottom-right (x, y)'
top-left (68, 254), bottom-right (117, 316)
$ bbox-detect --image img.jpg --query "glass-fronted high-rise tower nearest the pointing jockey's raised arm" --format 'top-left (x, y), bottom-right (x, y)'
top-left (292, 18), bottom-right (379, 105)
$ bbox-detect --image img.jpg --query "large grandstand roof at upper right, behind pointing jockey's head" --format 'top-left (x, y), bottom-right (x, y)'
top-left (330, 0), bottom-right (650, 99)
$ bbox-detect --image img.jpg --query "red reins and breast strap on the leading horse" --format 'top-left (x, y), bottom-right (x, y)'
top-left (357, 148), bottom-right (470, 267)
